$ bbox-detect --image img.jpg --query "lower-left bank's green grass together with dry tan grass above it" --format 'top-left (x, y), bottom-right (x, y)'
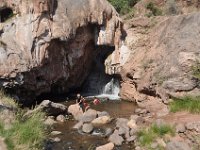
top-left (0, 91), bottom-right (46, 150)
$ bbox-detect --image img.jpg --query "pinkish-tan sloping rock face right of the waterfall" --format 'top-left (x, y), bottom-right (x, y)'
top-left (121, 13), bottom-right (200, 101)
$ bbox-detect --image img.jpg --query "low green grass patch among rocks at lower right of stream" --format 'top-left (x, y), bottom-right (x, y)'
top-left (137, 124), bottom-right (175, 149)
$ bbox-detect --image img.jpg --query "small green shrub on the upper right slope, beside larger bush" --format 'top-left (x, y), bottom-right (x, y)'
top-left (146, 2), bottom-right (162, 17)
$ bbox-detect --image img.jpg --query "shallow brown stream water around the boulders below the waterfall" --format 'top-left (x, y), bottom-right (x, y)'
top-left (49, 100), bottom-right (136, 150)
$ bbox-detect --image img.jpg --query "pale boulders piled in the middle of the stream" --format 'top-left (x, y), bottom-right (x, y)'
top-left (68, 104), bottom-right (145, 150)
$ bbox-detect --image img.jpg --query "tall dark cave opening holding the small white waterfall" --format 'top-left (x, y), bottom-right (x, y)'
top-left (80, 46), bottom-right (119, 96)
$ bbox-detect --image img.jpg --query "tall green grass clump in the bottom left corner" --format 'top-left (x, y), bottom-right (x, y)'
top-left (0, 112), bottom-right (46, 150)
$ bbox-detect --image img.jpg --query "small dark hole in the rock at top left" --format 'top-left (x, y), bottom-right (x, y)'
top-left (0, 8), bottom-right (14, 23)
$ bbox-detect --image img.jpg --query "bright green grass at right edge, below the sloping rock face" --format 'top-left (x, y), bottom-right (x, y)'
top-left (170, 96), bottom-right (200, 113)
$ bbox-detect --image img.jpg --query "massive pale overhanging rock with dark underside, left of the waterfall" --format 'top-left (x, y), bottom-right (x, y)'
top-left (0, 0), bottom-right (122, 103)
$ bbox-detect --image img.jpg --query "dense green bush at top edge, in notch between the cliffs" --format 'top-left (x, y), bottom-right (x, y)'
top-left (108, 0), bottom-right (139, 15)
